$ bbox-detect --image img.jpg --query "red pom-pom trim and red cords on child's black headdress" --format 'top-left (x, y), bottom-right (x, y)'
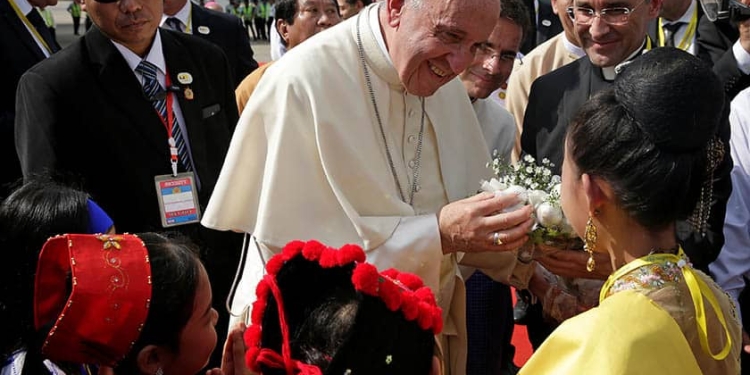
top-left (245, 241), bottom-right (443, 375)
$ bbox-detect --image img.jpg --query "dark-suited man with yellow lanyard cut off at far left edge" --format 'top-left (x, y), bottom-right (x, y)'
top-left (0, 0), bottom-right (60, 201)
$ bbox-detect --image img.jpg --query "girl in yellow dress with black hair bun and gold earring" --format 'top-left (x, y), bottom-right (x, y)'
top-left (521, 48), bottom-right (741, 375)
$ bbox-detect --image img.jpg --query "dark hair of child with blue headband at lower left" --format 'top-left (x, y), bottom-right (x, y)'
top-left (0, 176), bottom-right (89, 374)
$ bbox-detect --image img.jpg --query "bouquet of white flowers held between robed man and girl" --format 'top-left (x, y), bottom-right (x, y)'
top-left (480, 153), bottom-right (583, 255)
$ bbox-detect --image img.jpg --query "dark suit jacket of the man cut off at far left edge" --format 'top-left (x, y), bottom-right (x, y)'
top-left (0, 0), bottom-right (59, 200)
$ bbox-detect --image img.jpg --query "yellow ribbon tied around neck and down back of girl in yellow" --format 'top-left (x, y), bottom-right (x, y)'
top-left (599, 248), bottom-right (732, 360)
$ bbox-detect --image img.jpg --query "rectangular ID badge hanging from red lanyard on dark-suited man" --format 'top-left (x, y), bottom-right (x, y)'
top-left (154, 172), bottom-right (201, 228)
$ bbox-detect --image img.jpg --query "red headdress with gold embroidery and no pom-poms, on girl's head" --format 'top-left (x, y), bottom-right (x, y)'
top-left (34, 234), bottom-right (151, 366)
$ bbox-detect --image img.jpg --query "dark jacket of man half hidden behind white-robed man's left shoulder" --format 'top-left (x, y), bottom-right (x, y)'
top-left (191, 4), bottom-right (258, 88)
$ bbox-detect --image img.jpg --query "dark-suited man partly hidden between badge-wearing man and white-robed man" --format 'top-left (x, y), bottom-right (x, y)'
top-left (161, 0), bottom-right (258, 87)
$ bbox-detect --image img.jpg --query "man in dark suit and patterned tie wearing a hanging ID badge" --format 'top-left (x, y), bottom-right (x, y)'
top-left (15, 0), bottom-right (242, 365)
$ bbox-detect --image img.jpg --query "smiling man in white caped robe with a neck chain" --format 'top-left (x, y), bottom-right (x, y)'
top-left (203, 0), bottom-right (532, 374)
